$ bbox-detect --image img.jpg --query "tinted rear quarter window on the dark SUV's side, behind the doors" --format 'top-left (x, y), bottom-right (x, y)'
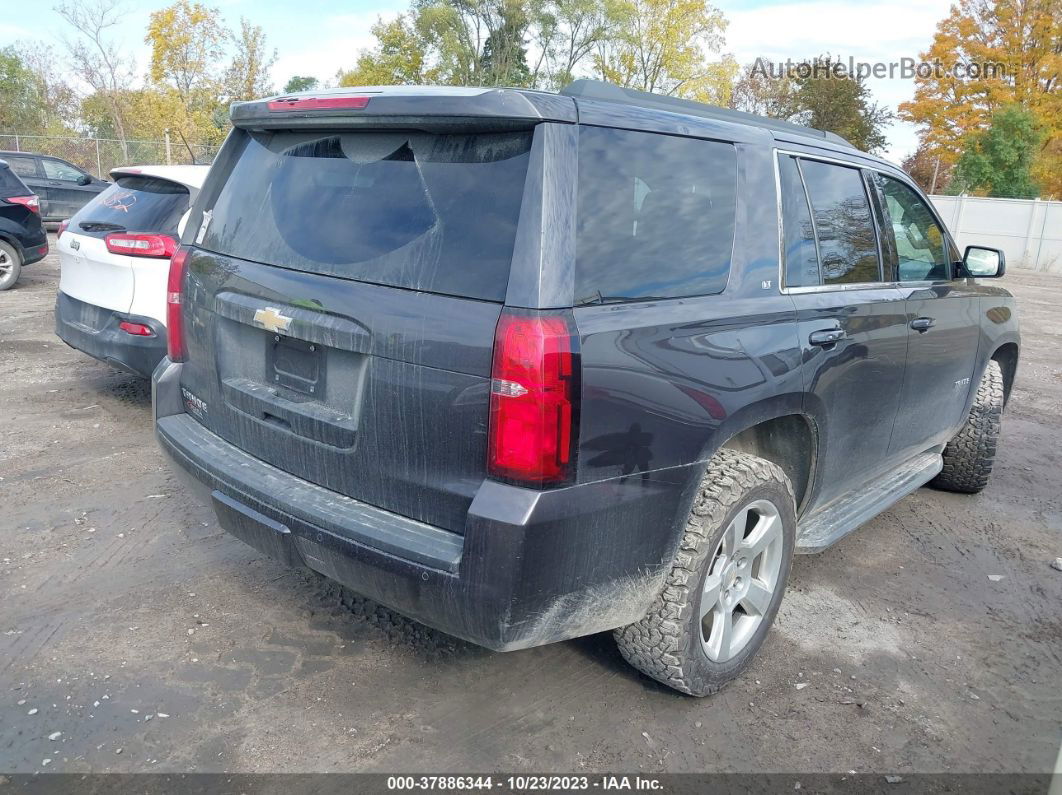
top-left (576, 127), bottom-right (737, 304)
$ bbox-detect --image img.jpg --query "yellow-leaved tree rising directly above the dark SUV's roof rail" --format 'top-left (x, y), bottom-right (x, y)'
top-left (595, 0), bottom-right (738, 104)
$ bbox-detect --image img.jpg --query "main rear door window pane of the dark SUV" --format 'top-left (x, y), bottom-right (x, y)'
top-left (800, 159), bottom-right (881, 284)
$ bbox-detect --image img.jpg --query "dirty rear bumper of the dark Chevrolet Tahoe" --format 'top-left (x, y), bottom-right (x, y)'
top-left (153, 360), bottom-right (696, 651)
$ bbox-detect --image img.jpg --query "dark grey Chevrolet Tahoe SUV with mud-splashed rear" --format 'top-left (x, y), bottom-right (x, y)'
top-left (154, 82), bottom-right (1020, 695)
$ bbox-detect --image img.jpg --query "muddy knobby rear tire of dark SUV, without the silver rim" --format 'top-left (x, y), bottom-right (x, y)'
top-left (614, 450), bottom-right (797, 696)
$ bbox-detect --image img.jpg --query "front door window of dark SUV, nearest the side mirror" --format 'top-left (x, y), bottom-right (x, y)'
top-left (875, 174), bottom-right (950, 281)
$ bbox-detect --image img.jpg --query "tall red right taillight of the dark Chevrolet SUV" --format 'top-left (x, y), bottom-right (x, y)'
top-left (487, 311), bottom-right (579, 486)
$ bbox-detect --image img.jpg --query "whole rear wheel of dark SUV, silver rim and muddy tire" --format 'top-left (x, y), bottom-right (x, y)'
top-left (615, 450), bottom-right (797, 696)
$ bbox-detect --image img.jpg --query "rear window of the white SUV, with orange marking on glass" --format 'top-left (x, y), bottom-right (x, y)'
top-left (70, 175), bottom-right (189, 238)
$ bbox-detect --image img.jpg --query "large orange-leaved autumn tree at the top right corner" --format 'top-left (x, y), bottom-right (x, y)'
top-left (900, 0), bottom-right (1062, 195)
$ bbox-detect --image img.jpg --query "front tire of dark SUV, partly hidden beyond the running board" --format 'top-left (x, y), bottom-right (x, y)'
top-left (929, 360), bottom-right (1004, 495)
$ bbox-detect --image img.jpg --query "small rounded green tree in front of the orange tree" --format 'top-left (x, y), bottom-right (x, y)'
top-left (952, 104), bottom-right (1044, 198)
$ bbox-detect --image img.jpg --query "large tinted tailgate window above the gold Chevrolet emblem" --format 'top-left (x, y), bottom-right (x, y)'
top-left (202, 132), bottom-right (531, 301)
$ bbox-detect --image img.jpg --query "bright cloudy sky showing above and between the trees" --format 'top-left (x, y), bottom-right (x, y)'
top-left (0, 0), bottom-right (952, 162)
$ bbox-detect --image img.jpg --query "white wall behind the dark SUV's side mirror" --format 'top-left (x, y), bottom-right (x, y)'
top-left (929, 196), bottom-right (1062, 274)
